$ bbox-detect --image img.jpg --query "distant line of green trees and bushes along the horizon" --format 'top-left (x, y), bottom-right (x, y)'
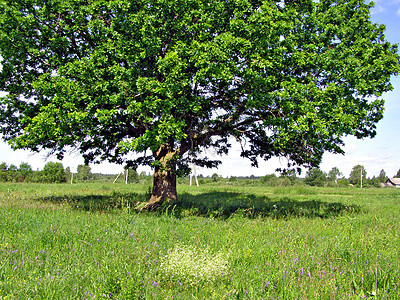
top-left (0, 162), bottom-right (400, 187)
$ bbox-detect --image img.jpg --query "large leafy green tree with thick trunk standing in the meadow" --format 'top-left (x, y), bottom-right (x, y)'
top-left (0, 0), bottom-right (399, 204)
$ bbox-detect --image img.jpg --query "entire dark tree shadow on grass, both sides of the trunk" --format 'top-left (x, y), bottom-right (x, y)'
top-left (38, 192), bottom-right (361, 219)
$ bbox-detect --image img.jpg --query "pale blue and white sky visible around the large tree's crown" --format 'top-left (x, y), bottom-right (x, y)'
top-left (0, 0), bottom-right (400, 177)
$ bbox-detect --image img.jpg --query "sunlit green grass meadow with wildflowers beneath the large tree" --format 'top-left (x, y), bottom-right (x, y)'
top-left (0, 183), bottom-right (400, 299)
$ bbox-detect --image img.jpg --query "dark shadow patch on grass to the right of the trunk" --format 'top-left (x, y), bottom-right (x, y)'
top-left (166, 192), bottom-right (361, 219)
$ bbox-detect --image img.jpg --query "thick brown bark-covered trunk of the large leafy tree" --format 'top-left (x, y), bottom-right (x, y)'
top-left (146, 145), bottom-right (178, 209)
